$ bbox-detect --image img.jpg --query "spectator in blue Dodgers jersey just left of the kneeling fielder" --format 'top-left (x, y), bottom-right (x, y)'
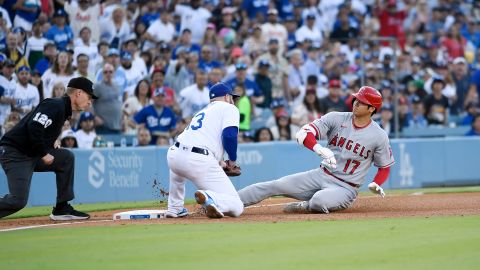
top-left (133, 88), bottom-right (176, 145)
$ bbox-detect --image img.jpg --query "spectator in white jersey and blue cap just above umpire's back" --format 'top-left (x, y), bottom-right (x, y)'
top-left (14, 66), bottom-right (40, 117)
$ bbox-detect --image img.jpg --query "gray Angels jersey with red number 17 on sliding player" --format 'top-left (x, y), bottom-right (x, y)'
top-left (312, 112), bottom-right (395, 185)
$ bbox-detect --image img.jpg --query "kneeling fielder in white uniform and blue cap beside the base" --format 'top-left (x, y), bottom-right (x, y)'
top-left (166, 83), bottom-right (243, 218)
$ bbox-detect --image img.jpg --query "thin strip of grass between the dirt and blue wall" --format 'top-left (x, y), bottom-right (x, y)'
top-left (6, 186), bottom-right (480, 219)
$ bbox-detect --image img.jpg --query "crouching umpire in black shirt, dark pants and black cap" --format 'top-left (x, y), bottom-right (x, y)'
top-left (0, 77), bottom-right (97, 220)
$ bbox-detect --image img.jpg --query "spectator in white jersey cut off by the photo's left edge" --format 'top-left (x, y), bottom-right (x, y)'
top-left (0, 55), bottom-right (17, 129)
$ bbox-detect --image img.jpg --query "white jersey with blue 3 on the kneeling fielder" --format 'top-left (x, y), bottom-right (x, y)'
top-left (177, 101), bottom-right (240, 161)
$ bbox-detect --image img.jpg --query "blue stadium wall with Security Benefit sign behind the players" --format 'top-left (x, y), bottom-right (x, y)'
top-left (0, 137), bottom-right (480, 206)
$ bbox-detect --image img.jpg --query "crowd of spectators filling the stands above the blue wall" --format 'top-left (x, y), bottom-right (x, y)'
top-left (0, 0), bottom-right (480, 148)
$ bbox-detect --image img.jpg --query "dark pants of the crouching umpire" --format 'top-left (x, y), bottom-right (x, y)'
top-left (0, 146), bottom-right (75, 218)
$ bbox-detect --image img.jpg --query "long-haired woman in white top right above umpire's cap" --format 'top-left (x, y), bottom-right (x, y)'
top-left (42, 52), bottom-right (74, 97)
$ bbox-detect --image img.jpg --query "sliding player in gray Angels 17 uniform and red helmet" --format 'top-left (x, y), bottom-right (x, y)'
top-left (238, 86), bottom-right (395, 213)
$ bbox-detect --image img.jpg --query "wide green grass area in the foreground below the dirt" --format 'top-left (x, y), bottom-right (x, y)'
top-left (0, 216), bottom-right (480, 270)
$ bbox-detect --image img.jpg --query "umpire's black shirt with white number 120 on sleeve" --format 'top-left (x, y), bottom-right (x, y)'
top-left (0, 96), bottom-right (72, 157)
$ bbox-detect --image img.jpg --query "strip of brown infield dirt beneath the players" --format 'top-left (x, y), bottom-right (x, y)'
top-left (0, 192), bottom-right (480, 229)
